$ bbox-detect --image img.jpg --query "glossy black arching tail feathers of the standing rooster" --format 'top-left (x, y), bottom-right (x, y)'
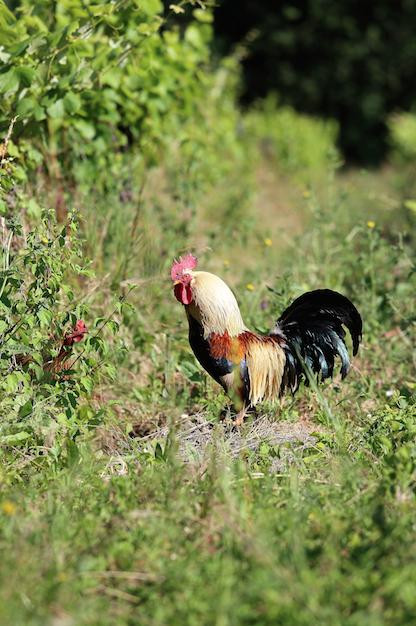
top-left (270, 289), bottom-right (362, 393)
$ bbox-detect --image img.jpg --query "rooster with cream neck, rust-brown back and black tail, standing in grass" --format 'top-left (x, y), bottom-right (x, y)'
top-left (171, 254), bottom-right (362, 426)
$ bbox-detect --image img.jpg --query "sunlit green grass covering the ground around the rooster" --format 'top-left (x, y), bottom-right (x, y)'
top-left (0, 147), bottom-right (416, 626)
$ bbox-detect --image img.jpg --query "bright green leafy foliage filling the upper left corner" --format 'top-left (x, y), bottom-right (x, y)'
top-left (0, 0), bottom-right (234, 182)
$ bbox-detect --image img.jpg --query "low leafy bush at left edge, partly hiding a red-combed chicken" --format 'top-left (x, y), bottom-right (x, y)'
top-left (0, 129), bottom-right (122, 456)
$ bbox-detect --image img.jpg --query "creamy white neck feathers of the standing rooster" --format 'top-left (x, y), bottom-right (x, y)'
top-left (188, 271), bottom-right (247, 339)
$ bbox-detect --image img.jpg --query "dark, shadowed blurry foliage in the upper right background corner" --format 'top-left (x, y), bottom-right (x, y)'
top-left (215, 0), bottom-right (416, 163)
